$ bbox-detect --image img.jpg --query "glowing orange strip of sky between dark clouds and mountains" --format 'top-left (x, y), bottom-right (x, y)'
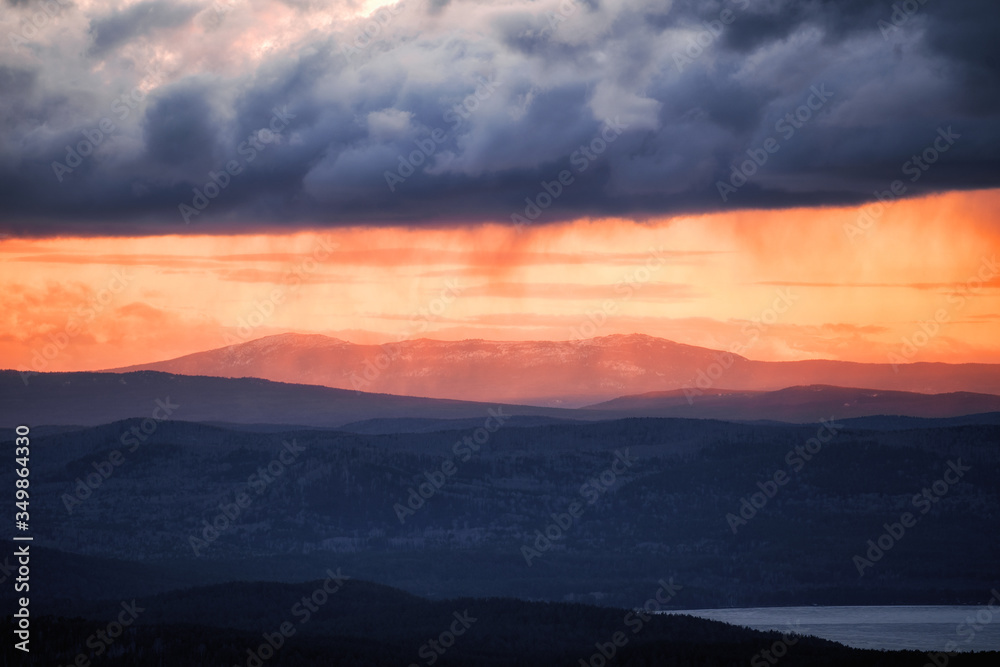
top-left (0, 190), bottom-right (1000, 371)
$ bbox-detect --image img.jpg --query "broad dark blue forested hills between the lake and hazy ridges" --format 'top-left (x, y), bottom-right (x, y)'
top-left (13, 419), bottom-right (1000, 612)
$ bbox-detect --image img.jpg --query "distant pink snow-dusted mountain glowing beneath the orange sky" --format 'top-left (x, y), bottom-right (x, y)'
top-left (112, 333), bottom-right (1000, 407)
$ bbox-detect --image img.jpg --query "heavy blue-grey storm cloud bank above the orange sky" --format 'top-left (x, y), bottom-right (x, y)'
top-left (0, 0), bottom-right (1000, 234)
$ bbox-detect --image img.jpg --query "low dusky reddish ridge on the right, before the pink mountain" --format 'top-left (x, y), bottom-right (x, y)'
top-left (588, 385), bottom-right (1000, 423)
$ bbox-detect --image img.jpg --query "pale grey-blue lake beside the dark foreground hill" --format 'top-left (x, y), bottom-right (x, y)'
top-left (665, 605), bottom-right (1000, 651)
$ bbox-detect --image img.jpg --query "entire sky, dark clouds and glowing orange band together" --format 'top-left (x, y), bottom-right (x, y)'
top-left (0, 0), bottom-right (1000, 370)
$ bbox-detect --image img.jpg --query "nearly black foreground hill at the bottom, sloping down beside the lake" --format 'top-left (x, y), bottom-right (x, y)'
top-left (25, 571), bottom-right (984, 667)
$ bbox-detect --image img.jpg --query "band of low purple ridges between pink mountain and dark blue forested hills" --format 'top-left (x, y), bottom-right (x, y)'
top-left (0, 371), bottom-right (1000, 433)
